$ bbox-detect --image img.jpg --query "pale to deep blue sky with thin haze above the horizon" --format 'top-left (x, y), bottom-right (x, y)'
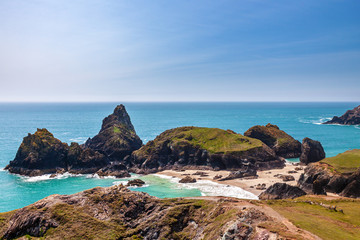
top-left (0, 0), bottom-right (360, 102)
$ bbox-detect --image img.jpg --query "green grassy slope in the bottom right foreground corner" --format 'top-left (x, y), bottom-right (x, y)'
top-left (266, 196), bottom-right (360, 240)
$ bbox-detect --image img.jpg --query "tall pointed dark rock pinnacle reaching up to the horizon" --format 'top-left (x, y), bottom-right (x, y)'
top-left (85, 104), bottom-right (142, 161)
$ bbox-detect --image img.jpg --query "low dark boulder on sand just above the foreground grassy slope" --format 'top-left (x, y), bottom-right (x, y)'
top-left (259, 183), bottom-right (306, 200)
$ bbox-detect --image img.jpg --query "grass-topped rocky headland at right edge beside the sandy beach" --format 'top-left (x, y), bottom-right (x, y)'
top-left (298, 149), bottom-right (360, 198)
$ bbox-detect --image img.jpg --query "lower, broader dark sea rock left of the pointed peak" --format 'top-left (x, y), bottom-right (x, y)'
top-left (5, 128), bottom-right (108, 176)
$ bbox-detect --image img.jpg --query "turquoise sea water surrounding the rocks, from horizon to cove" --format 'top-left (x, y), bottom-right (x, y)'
top-left (0, 103), bottom-right (360, 212)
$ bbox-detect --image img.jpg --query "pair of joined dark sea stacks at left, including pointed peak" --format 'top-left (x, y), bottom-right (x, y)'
top-left (5, 105), bottom-right (142, 177)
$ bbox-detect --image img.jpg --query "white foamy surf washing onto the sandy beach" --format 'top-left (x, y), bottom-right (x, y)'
top-left (179, 180), bottom-right (258, 199)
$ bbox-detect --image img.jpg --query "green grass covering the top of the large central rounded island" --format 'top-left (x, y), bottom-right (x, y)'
top-left (136, 127), bottom-right (262, 153)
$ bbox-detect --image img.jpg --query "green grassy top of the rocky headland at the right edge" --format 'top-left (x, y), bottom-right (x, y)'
top-left (321, 149), bottom-right (360, 173)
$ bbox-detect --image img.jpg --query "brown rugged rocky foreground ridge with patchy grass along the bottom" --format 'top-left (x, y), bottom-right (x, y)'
top-left (0, 185), bottom-right (310, 240)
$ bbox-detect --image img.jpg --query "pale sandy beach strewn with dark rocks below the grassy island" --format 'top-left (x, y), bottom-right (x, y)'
top-left (157, 162), bottom-right (304, 196)
